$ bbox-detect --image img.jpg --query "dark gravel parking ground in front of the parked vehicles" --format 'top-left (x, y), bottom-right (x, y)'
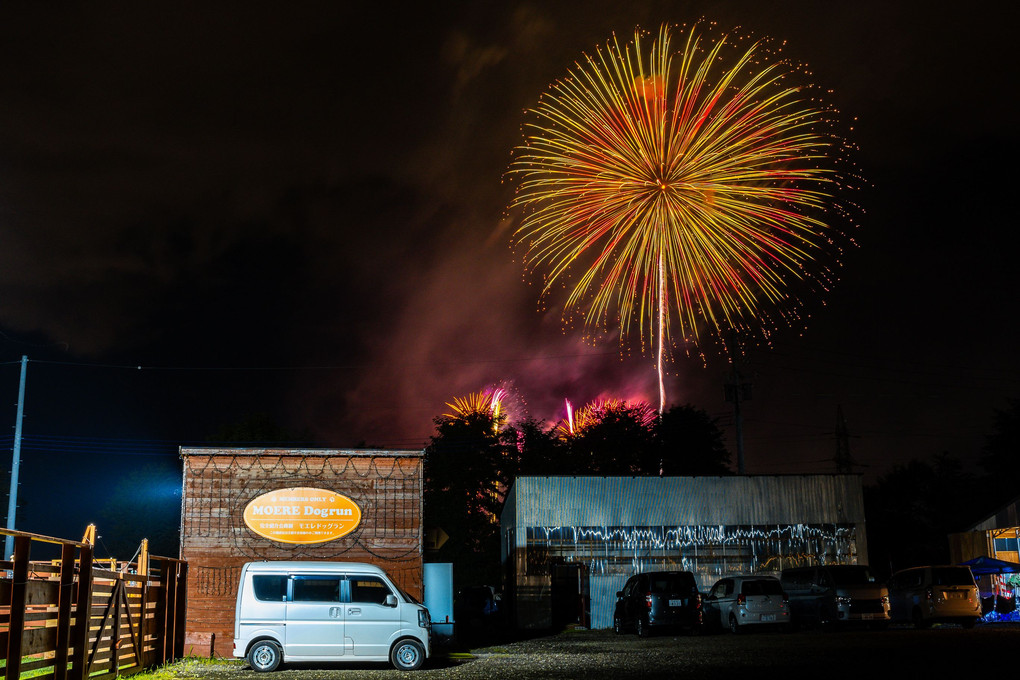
top-left (187, 624), bottom-right (1020, 680)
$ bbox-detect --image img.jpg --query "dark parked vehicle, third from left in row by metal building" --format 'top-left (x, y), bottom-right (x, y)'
top-left (779, 565), bottom-right (889, 628)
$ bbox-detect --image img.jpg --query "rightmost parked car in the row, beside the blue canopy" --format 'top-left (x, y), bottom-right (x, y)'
top-left (888, 567), bottom-right (981, 628)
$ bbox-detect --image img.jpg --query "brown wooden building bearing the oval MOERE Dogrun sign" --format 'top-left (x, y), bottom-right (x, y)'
top-left (181, 448), bottom-right (423, 658)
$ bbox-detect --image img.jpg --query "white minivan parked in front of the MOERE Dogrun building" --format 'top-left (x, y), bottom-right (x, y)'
top-left (234, 562), bottom-right (431, 671)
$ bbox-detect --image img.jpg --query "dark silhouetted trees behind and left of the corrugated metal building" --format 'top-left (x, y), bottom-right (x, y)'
top-left (424, 399), bottom-right (732, 582)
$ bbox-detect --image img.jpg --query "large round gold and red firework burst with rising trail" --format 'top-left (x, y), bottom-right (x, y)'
top-left (510, 22), bottom-right (850, 412)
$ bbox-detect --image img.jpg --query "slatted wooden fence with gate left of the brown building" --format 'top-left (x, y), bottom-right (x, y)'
top-left (0, 529), bottom-right (188, 680)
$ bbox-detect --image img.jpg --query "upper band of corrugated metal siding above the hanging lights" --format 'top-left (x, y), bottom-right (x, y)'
top-left (504, 475), bottom-right (864, 533)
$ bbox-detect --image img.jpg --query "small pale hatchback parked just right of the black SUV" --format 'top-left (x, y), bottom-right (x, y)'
top-left (704, 576), bottom-right (789, 633)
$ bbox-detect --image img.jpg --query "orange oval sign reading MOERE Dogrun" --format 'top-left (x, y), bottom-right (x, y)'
top-left (245, 486), bottom-right (361, 543)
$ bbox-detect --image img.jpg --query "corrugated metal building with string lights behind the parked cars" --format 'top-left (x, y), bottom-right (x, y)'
top-left (500, 475), bottom-right (868, 628)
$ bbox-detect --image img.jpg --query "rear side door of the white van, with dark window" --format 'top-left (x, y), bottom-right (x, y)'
top-left (284, 574), bottom-right (346, 659)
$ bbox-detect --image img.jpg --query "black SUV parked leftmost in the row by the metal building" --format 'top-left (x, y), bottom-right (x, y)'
top-left (613, 571), bottom-right (702, 637)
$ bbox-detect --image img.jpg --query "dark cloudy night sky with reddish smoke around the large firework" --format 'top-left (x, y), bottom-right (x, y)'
top-left (0, 0), bottom-right (1020, 554)
